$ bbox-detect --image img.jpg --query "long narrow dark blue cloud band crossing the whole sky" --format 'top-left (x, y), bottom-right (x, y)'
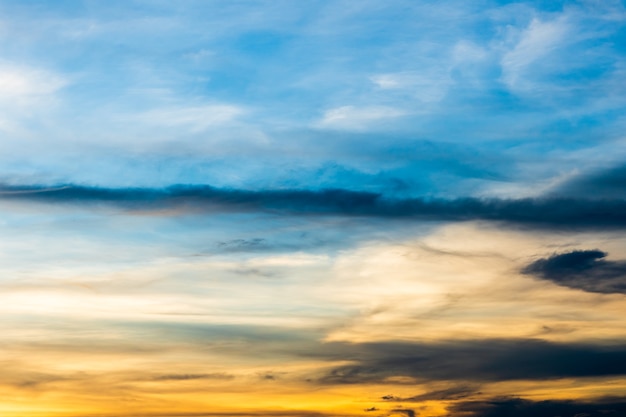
top-left (0, 185), bottom-right (626, 228)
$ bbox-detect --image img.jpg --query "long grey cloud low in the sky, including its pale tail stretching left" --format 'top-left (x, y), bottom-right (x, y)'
top-left (83, 323), bottom-right (626, 386)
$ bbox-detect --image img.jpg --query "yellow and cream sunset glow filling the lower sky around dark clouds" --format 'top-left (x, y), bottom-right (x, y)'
top-left (0, 223), bottom-right (626, 417)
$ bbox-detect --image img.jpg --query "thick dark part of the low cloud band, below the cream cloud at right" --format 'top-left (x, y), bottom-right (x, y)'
top-left (318, 339), bottom-right (626, 384)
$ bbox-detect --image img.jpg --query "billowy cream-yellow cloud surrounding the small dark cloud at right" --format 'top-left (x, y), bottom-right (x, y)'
top-left (324, 223), bottom-right (624, 342)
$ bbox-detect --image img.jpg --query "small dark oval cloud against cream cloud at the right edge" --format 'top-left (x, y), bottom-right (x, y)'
top-left (522, 249), bottom-right (626, 294)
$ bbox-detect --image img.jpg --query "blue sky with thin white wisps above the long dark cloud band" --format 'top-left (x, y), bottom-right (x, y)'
top-left (0, 1), bottom-right (626, 196)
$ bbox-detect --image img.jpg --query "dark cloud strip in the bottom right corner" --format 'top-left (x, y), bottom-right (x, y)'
top-left (448, 398), bottom-right (626, 417)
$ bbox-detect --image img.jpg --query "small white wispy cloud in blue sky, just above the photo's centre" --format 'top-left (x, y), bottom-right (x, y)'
top-left (318, 106), bottom-right (408, 129)
